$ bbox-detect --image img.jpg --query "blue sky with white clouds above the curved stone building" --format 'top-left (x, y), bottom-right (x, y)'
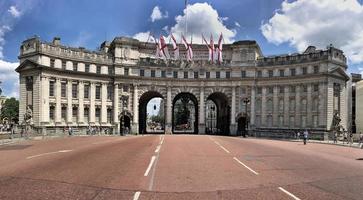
top-left (0, 0), bottom-right (363, 97)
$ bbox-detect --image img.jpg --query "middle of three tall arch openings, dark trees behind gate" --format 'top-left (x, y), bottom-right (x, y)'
top-left (172, 93), bottom-right (198, 134)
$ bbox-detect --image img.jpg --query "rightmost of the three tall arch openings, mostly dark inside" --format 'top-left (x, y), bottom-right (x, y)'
top-left (206, 92), bottom-right (231, 135)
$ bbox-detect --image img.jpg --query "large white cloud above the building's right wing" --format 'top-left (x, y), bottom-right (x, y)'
top-left (261, 0), bottom-right (363, 63)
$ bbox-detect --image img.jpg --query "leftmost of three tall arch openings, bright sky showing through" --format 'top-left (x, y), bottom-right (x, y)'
top-left (139, 91), bottom-right (165, 134)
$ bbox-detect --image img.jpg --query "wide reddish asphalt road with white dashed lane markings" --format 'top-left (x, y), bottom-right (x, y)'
top-left (0, 135), bottom-right (363, 200)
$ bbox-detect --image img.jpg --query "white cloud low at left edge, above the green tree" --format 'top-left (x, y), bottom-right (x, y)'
top-left (0, 60), bottom-right (19, 98)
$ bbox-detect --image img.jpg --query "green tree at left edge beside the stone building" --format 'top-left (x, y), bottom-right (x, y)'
top-left (0, 98), bottom-right (19, 122)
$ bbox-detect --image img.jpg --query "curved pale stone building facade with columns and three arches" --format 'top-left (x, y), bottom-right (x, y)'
top-left (16, 37), bottom-right (349, 138)
